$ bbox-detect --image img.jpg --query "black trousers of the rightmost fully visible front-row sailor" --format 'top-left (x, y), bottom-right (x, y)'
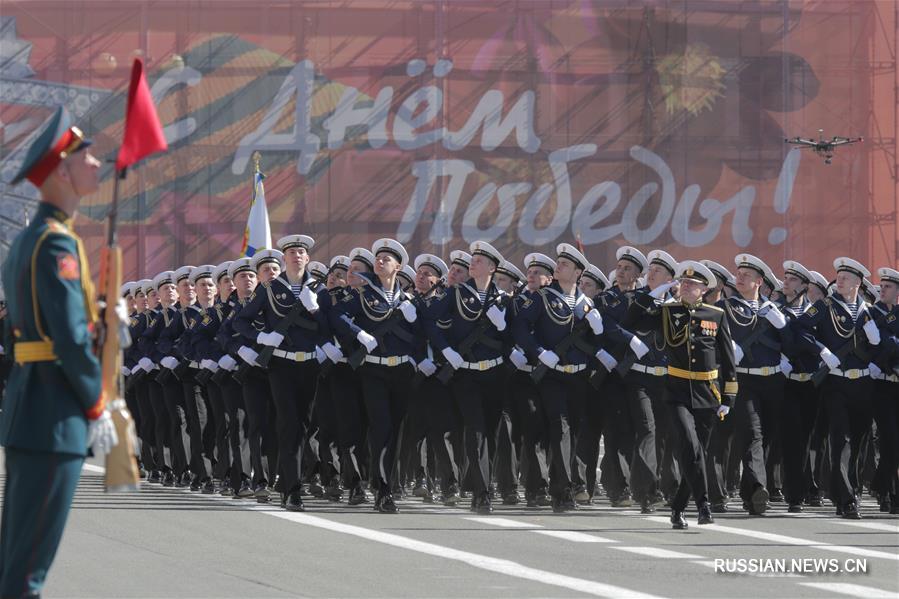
top-left (824, 375), bottom-right (873, 508)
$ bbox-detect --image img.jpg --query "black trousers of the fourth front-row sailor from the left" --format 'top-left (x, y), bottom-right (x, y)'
top-left (537, 370), bottom-right (598, 498)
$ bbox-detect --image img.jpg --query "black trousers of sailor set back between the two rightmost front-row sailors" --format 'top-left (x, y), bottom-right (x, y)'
top-left (780, 379), bottom-right (818, 505)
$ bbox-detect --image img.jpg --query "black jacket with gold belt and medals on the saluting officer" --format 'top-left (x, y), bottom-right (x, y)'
top-left (623, 294), bottom-right (738, 409)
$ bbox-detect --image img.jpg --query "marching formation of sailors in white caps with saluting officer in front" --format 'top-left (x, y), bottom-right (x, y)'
top-left (110, 235), bottom-right (899, 529)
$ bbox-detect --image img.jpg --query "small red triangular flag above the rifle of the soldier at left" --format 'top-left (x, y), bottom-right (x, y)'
top-left (116, 58), bottom-right (169, 170)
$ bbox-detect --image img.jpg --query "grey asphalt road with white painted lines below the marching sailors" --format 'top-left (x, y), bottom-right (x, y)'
top-left (1, 454), bottom-right (899, 599)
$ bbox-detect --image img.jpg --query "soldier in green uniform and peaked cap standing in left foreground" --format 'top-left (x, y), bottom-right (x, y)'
top-left (0, 108), bottom-right (117, 597)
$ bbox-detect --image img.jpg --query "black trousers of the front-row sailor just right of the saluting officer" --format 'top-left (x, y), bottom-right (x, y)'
top-left (728, 374), bottom-right (768, 503)
